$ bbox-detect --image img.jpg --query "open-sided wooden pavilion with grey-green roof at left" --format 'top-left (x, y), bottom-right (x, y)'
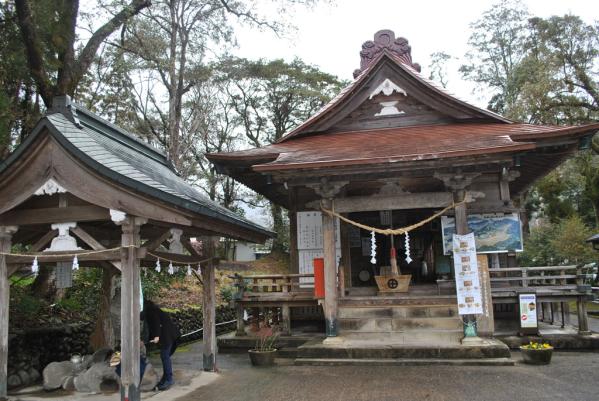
top-left (0, 97), bottom-right (272, 401)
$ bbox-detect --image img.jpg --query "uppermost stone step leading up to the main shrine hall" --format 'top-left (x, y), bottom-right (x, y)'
top-left (338, 304), bottom-right (458, 318)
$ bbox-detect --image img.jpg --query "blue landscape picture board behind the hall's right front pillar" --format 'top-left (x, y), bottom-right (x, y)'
top-left (441, 213), bottom-right (524, 255)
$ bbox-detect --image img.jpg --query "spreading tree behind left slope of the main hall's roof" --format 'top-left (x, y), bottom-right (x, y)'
top-left (217, 58), bottom-right (343, 253)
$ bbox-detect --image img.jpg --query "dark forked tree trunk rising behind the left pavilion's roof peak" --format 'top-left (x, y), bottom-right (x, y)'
top-left (15, 0), bottom-right (151, 107)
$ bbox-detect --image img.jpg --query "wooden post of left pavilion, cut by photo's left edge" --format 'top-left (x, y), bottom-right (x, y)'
top-left (0, 226), bottom-right (17, 400)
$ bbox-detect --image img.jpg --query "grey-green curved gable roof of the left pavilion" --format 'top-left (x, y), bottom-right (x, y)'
top-left (0, 100), bottom-right (272, 237)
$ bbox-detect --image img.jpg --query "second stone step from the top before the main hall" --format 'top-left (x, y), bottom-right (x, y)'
top-left (338, 317), bottom-right (462, 333)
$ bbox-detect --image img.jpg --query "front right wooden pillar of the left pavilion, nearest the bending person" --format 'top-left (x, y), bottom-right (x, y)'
top-left (120, 216), bottom-right (145, 401)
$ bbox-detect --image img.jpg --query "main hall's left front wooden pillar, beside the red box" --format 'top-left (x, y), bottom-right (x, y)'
top-left (322, 199), bottom-right (337, 337)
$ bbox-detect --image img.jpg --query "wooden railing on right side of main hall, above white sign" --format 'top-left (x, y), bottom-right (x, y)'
top-left (489, 265), bottom-right (591, 292)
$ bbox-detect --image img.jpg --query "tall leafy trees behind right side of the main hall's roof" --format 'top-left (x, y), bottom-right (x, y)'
top-left (461, 1), bottom-right (599, 224)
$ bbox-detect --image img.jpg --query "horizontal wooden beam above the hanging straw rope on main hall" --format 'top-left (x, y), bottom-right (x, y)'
top-left (308, 192), bottom-right (452, 213)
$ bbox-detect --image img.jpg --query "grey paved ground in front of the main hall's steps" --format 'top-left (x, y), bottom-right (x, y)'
top-left (176, 352), bottom-right (599, 401)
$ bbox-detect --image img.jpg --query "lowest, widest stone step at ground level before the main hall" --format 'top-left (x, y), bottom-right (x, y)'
top-left (295, 358), bottom-right (515, 366)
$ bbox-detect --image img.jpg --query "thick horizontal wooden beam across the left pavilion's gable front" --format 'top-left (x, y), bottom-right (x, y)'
top-left (0, 206), bottom-right (110, 226)
